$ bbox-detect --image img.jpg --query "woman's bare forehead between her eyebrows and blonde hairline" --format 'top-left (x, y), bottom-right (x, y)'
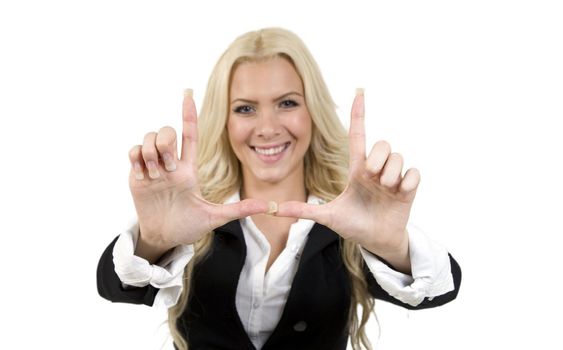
top-left (230, 57), bottom-right (303, 98)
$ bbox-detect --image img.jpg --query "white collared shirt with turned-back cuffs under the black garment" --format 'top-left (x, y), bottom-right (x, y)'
top-left (113, 192), bottom-right (454, 349)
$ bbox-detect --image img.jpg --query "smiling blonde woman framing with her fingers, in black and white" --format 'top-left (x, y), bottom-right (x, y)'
top-left (98, 28), bottom-right (461, 350)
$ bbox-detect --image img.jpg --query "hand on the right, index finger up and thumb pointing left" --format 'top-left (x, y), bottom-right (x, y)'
top-left (276, 92), bottom-right (420, 272)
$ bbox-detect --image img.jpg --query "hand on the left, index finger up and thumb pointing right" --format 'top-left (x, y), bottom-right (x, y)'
top-left (129, 90), bottom-right (268, 263)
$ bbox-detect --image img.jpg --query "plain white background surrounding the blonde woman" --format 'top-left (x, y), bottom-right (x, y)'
top-left (0, 0), bottom-right (563, 350)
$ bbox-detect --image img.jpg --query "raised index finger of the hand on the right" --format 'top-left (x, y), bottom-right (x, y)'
top-left (349, 89), bottom-right (366, 167)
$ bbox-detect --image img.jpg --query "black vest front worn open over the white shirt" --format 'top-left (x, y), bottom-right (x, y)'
top-left (178, 221), bottom-right (351, 350)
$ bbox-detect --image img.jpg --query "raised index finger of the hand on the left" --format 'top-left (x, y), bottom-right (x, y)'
top-left (180, 89), bottom-right (197, 165)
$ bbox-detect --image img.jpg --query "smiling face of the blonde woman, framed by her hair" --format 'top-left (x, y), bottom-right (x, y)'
top-left (227, 57), bottom-right (312, 184)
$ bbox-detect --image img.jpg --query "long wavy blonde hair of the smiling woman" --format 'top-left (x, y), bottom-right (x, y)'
top-left (168, 28), bottom-right (374, 350)
